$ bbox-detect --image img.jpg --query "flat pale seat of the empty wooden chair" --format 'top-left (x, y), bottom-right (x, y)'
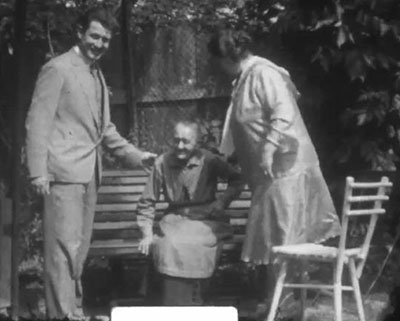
top-left (272, 243), bottom-right (361, 261)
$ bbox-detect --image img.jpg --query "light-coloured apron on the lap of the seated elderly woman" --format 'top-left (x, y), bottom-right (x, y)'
top-left (152, 206), bottom-right (232, 278)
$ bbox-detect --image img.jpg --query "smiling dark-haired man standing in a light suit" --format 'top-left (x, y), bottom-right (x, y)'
top-left (26, 9), bottom-right (156, 319)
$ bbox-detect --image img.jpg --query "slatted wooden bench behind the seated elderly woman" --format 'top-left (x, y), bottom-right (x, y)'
top-left (89, 170), bottom-right (251, 262)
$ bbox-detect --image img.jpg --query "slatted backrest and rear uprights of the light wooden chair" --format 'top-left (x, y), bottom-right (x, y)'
top-left (337, 176), bottom-right (392, 277)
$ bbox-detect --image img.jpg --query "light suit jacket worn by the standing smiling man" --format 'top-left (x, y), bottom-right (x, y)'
top-left (26, 48), bottom-right (142, 183)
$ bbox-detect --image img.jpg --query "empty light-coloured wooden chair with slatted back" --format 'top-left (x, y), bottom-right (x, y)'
top-left (266, 177), bottom-right (392, 321)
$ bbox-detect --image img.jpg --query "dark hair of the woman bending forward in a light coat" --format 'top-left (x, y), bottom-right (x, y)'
top-left (208, 29), bottom-right (252, 61)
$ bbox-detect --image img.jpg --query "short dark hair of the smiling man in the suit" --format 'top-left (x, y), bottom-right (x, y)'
top-left (76, 7), bottom-right (118, 32)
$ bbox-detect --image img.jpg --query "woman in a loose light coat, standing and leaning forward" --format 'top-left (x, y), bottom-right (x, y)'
top-left (208, 30), bottom-right (340, 298)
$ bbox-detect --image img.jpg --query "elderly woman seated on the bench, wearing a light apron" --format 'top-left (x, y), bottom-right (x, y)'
top-left (137, 120), bottom-right (243, 306)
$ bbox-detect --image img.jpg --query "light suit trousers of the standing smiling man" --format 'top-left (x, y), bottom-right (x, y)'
top-left (43, 178), bottom-right (97, 319)
